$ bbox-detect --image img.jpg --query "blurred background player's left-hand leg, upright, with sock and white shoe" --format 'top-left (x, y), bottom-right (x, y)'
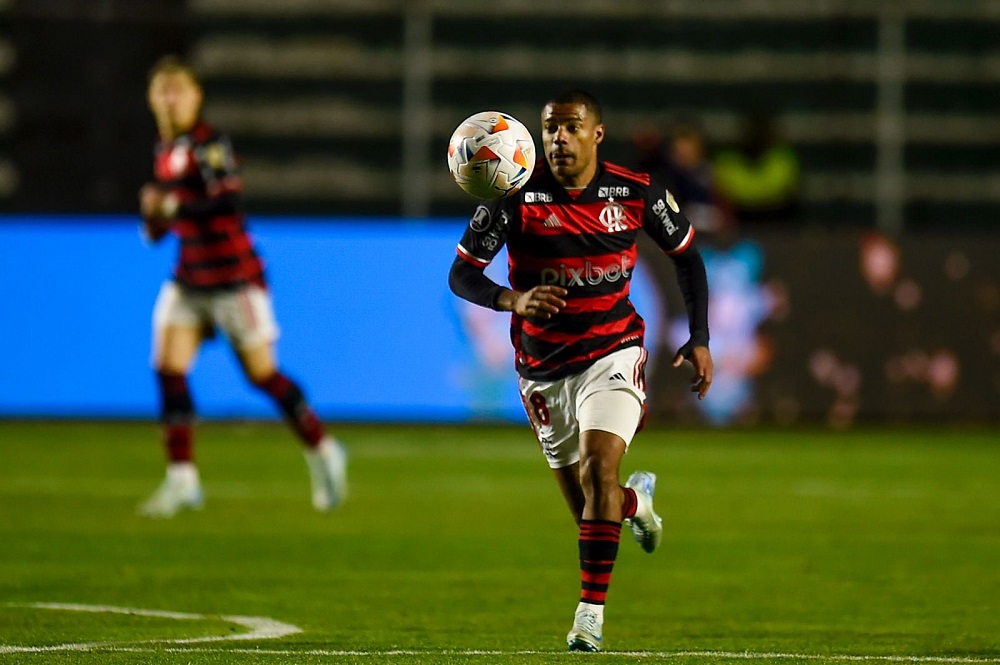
top-left (139, 325), bottom-right (204, 518)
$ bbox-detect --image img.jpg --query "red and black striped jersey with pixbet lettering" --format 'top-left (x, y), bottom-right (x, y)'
top-left (458, 160), bottom-right (694, 381)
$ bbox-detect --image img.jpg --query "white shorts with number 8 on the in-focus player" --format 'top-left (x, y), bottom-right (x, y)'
top-left (518, 346), bottom-right (647, 469)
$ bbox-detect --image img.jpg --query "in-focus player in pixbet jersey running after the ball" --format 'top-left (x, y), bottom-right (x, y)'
top-left (449, 90), bottom-right (712, 651)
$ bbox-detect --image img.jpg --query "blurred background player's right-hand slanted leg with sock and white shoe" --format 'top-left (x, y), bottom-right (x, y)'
top-left (236, 344), bottom-right (347, 511)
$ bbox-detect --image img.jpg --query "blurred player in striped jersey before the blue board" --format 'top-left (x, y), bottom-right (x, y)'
top-left (139, 56), bottom-right (347, 517)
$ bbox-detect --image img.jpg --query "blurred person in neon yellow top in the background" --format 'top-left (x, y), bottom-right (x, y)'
top-left (714, 110), bottom-right (799, 224)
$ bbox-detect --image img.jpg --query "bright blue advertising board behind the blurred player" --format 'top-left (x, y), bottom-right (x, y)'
top-left (0, 217), bottom-right (524, 421)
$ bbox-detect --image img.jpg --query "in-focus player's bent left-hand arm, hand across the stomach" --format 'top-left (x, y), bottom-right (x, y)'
top-left (448, 199), bottom-right (566, 319)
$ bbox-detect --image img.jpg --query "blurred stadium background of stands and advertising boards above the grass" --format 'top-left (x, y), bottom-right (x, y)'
top-left (0, 0), bottom-right (1000, 426)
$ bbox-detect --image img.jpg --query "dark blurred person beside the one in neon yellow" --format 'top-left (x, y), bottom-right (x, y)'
top-left (632, 121), bottom-right (729, 235)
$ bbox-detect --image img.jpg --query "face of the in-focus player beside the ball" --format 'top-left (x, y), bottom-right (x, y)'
top-left (542, 104), bottom-right (604, 187)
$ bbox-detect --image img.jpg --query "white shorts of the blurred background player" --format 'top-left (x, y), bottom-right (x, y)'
top-left (153, 281), bottom-right (279, 350)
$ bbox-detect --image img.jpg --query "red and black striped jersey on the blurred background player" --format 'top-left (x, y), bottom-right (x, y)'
top-left (154, 122), bottom-right (264, 290)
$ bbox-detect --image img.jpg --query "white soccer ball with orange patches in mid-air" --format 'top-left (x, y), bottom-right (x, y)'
top-left (448, 111), bottom-right (535, 199)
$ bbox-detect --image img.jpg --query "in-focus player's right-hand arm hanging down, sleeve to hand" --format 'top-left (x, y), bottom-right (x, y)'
top-left (643, 183), bottom-right (714, 399)
